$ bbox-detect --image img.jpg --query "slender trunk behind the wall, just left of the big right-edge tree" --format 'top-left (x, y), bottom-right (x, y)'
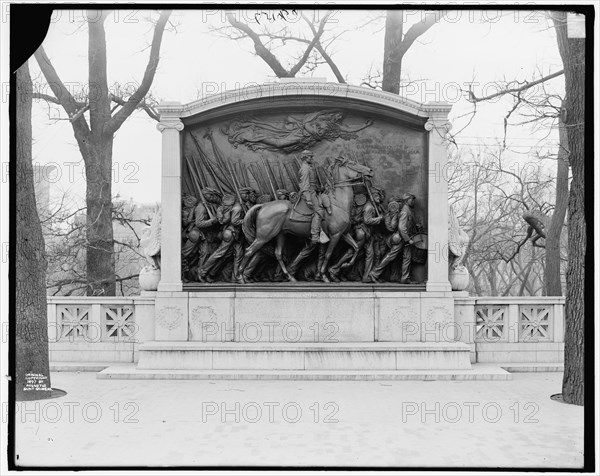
top-left (544, 106), bottom-right (569, 296)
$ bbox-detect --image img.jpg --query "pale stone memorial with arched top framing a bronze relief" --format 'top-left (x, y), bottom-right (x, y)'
top-left (125, 79), bottom-right (478, 378)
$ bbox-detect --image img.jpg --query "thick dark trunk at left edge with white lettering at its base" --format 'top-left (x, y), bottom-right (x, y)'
top-left (15, 63), bottom-right (52, 400)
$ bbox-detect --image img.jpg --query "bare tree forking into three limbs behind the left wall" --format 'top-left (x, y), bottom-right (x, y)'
top-left (35, 10), bottom-right (171, 295)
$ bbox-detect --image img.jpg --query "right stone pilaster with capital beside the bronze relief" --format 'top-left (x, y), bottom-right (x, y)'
top-left (424, 103), bottom-right (452, 292)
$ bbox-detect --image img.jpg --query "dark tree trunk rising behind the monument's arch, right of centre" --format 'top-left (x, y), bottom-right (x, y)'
top-left (381, 10), bottom-right (404, 94)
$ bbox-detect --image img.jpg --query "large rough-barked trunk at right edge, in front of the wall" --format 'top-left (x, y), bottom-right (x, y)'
top-left (552, 12), bottom-right (593, 405)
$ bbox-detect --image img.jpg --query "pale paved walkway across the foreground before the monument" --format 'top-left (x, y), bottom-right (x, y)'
top-left (16, 373), bottom-right (583, 468)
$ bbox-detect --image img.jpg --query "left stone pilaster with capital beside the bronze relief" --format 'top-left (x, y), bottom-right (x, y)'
top-left (157, 102), bottom-right (183, 292)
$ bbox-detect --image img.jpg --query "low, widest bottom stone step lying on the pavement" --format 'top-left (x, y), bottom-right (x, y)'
top-left (96, 364), bottom-right (512, 381)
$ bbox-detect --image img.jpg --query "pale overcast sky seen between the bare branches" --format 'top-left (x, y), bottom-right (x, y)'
top-left (30, 10), bottom-right (564, 207)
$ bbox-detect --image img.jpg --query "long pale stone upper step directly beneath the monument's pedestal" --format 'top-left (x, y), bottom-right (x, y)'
top-left (138, 341), bottom-right (471, 371)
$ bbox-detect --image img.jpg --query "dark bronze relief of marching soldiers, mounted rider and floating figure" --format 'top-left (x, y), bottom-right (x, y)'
top-left (182, 110), bottom-right (422, 284)
